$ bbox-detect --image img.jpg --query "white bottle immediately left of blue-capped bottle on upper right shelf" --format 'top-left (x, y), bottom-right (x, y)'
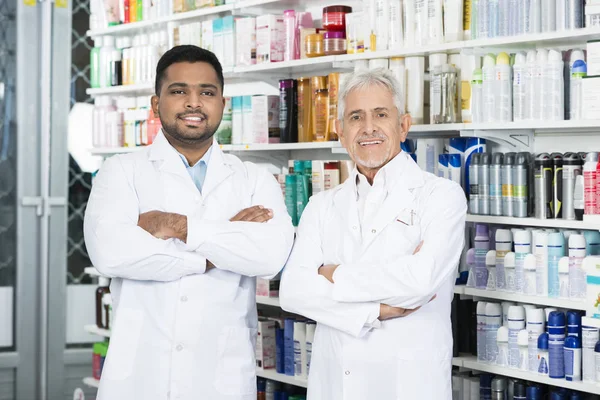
top-left (543, 50), bottom-right (565, 121)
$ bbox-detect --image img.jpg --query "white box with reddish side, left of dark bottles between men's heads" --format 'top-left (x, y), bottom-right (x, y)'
top-left (252, 96), bottom-right (280, 144)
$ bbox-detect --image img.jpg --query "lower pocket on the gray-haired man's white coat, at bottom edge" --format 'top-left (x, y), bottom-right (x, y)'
top-left (394, 347), bottom-right (452, 400)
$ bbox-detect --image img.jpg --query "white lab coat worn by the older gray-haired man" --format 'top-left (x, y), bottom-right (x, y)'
top-left (280, 153), bottom-right (467, 400)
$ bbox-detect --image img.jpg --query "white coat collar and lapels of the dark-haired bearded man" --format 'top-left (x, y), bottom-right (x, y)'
top-left (149, 130), bottom-right (233, 197)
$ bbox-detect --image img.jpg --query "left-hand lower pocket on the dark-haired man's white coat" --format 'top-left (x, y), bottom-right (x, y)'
top-left (102, 308), bottom-right (144, 380)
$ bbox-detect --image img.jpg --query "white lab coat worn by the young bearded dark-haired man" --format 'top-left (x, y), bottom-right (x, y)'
top-left (85, 133), bottom-right (294, 400)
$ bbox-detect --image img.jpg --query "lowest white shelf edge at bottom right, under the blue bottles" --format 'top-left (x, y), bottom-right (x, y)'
top-left (452, 356), bottom-right (600, 394)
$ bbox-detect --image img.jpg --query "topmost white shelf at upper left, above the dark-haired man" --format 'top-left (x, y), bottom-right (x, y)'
top-left (86, 4), bottom-right (235, 37)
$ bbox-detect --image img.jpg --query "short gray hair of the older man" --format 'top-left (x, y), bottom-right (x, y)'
top-left (338, 68), bottom-right (404, 123)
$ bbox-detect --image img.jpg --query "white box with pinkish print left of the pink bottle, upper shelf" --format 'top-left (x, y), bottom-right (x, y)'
top-left (256, 14), bottom-right (285, 64)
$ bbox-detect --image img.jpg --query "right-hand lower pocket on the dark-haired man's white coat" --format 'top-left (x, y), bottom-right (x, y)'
top-left (215, 327), bottom-right (256, 396)
